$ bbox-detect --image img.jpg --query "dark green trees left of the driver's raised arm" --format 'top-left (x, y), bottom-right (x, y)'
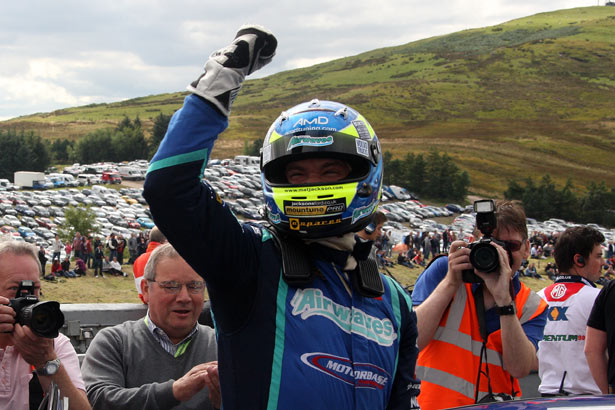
top-left (0, 113), bottom-right (171, 180)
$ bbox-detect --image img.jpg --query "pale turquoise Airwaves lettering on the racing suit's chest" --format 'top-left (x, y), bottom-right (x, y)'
top-left (290, 288), bottom-right (397, 346)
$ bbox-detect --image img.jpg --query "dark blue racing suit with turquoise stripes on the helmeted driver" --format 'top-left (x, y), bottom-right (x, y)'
top-left (143, 95), bottom-right (419, 410)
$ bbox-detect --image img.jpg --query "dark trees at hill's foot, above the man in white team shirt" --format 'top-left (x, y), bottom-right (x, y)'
top-left (504, 174), bottom-right (615, 227)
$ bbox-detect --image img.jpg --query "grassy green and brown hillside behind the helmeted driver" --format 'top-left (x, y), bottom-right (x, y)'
top-left (0, 6), bottom-right (615, 194)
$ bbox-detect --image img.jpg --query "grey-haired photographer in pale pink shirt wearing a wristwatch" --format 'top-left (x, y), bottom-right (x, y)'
top-left (0, 241), bottom-right (90, 410)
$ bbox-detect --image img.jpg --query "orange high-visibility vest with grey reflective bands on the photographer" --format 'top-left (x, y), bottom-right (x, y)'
top-left (416, 283), bottom-right (547, 410)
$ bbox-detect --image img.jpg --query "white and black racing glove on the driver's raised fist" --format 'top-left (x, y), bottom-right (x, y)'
top-left (187, 25), bottom-right (278, 117)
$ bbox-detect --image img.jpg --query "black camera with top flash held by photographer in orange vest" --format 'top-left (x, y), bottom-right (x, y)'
top-left (461, 199), bottom-right (513, 283)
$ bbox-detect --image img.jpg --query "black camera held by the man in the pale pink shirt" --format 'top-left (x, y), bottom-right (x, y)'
top-left (9, 280), bottom-right (64, 339)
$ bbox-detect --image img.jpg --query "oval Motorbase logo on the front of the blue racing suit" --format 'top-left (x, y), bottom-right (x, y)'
top-left (301, 353), bottom-right (391, 390)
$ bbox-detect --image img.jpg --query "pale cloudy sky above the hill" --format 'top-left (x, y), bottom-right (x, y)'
top-left (0, 0), bottom-right (604, 120)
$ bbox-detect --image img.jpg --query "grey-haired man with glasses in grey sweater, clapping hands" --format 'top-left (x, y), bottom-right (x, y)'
top-left (82, 244), bottom-right (221, 410)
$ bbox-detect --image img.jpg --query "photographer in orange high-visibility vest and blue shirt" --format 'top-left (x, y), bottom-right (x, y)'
top-left (412, 201), bottom-right (546, 410)
